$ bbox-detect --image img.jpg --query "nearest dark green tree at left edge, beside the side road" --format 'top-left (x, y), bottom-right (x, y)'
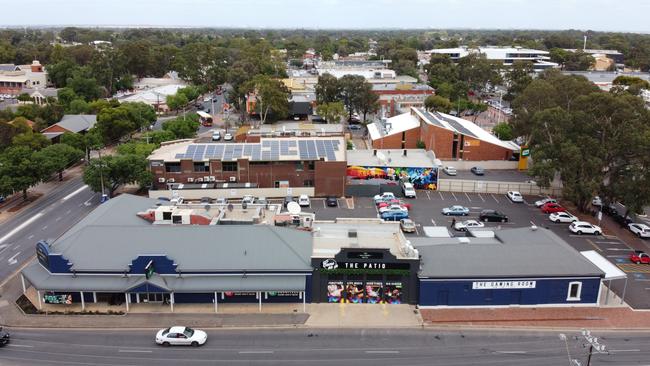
top-left (0, 146), bottom-right (46, 200)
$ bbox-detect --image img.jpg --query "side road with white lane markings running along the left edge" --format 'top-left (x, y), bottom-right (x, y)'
top-left (0, 177), bottom-right (100, 283)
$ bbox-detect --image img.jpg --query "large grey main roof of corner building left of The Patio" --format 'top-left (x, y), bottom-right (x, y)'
top-left (50, 195), bottom-right (312, 272)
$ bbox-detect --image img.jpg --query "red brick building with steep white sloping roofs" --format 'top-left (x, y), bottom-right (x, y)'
top-left (368, 108), bottom-right (519, 160)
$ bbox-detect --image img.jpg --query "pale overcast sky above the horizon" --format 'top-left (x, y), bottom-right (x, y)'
top-left (5, 0), bottom-right (650, 32)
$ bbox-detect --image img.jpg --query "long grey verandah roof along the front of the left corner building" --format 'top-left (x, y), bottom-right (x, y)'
top-left (22, 262), bottom-right (305, 292)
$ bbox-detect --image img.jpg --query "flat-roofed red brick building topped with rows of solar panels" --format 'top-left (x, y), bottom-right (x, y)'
top-left (149, 137), bottom-right (347, 196)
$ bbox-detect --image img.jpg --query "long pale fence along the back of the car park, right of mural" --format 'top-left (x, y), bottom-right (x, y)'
top-left (438, 179), bottom-right (562, 196)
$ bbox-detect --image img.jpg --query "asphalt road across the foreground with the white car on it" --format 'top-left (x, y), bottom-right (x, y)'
top-left (0, 328), bottom-right (650, 366)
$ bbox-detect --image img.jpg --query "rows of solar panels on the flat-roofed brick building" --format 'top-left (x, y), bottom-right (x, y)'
top-left (175, 140), bottom-right (342, 161)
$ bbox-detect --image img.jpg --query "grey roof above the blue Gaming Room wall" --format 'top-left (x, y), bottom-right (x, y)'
top-left (411, 228), bottom-right (604, 278)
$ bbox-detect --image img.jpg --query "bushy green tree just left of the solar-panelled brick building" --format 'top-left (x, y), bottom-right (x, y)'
top-left (83, 154), bottom-right (153, 197)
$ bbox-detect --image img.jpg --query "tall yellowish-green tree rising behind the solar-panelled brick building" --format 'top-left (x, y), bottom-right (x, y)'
top-left (243, 75), bottom-right (289, 124)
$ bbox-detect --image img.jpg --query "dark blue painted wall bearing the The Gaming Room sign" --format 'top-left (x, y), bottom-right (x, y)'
top-left (418, 278), bottom-right (600, 306)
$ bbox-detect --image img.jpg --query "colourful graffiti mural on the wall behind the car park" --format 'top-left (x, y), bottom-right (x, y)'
top-left (347, 166), bottom-right (438, 190)
